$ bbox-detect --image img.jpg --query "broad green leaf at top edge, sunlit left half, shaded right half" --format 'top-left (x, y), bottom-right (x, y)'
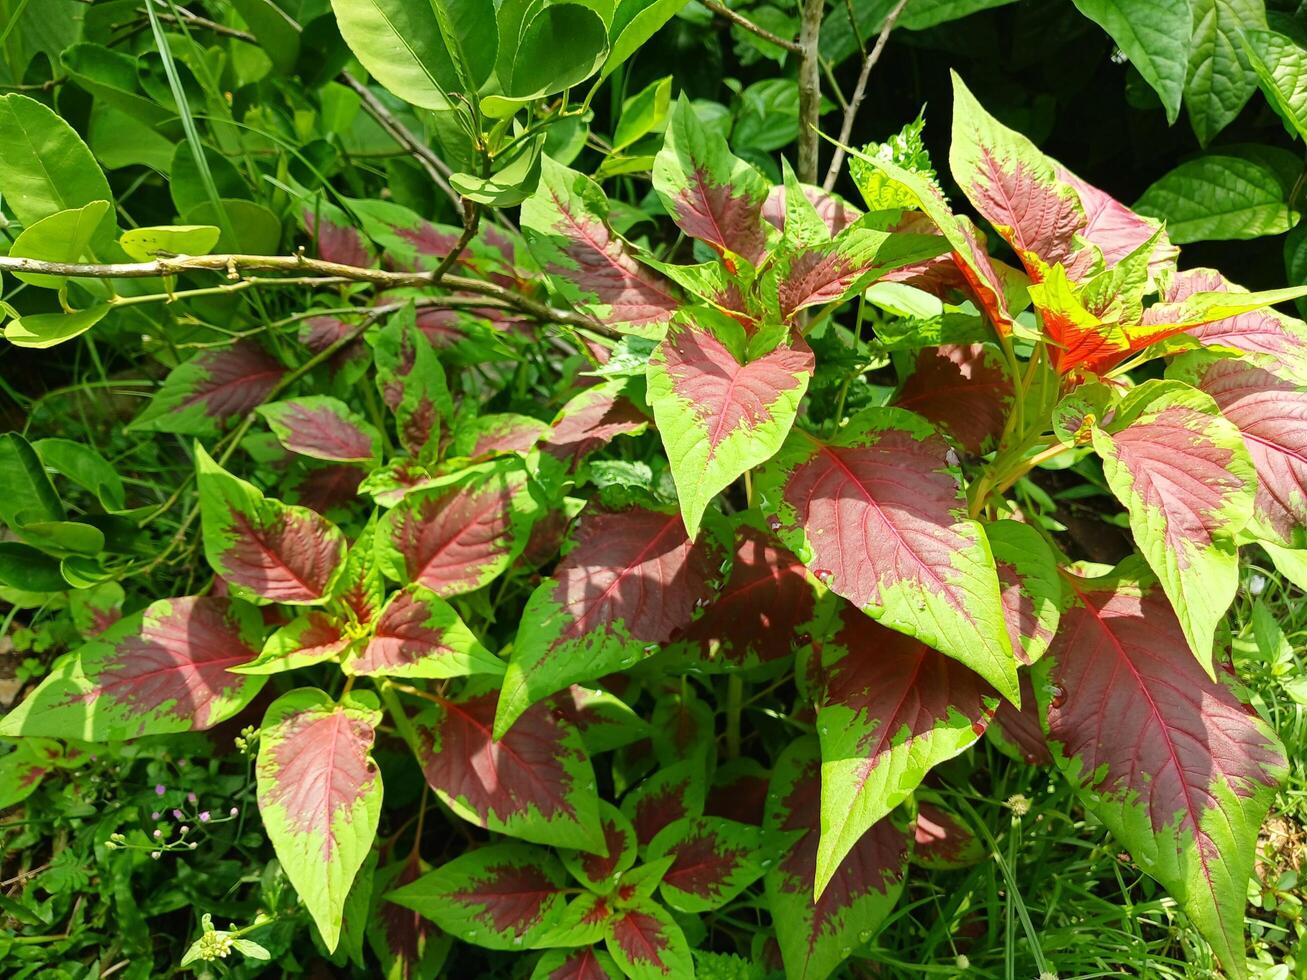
top-left (332, 0), bottom-right (498, 110)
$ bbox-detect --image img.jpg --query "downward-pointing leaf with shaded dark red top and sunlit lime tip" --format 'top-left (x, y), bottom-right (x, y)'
top-left (816, 606), bottom-right (999, 896)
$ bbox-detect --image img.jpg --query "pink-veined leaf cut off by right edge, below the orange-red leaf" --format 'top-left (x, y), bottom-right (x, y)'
top-left (1167, 353), bottom-right (1307, 549)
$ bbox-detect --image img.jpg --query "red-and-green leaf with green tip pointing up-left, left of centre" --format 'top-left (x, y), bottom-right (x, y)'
top-left (195, 444), bottom-right (345, 604)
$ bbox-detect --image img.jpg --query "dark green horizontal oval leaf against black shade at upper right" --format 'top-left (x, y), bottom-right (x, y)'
top-left (1134, 146), bottom-right (1299, 244)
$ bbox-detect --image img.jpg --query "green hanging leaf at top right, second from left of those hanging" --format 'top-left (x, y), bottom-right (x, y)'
top-left (1172, 0), bottom-right (1266, 145)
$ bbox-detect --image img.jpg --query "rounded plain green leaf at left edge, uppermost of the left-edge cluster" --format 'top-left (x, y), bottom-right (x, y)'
top-left (0, 93), bottom-right (114, 234)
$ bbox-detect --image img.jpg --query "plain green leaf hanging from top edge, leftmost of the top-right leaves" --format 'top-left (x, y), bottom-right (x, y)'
top-left (1074, 0), bottom-right (1193, 123)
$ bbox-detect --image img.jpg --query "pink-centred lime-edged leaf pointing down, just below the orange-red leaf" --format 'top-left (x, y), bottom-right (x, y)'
top-left (1093, 382), bottom-right (1257, 672)
